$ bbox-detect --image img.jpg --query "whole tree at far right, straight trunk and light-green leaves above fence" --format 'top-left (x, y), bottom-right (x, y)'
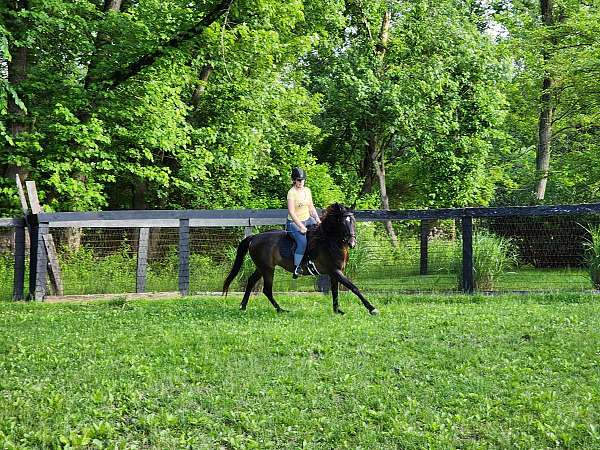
top-left (495, 0), bottom-right (600, 203)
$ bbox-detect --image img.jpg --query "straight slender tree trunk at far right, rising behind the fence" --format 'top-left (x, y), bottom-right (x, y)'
top-left (535, 0), bottom-right (554, 200)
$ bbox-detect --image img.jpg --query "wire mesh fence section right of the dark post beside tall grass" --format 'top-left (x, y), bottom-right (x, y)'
top-left (473, 215), bottom-right (600, 291)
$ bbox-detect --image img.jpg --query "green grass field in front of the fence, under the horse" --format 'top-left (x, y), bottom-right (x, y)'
top-left (0, 294), bottom-right (600, 449)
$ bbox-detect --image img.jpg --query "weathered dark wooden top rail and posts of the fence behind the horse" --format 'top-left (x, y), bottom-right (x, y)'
top-left (0, 203), bottom-right (600, 300)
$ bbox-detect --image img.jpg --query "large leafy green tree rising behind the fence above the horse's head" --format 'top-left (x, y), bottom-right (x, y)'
top-left (304, 1), bottom-right (504, 211)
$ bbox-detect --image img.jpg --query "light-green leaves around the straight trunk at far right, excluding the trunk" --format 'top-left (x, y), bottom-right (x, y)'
top-left (494, 1), bottom-right (600, 204)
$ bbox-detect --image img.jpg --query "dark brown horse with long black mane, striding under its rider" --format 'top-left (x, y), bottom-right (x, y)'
top-left (223, 203), bottom-right (379, 315)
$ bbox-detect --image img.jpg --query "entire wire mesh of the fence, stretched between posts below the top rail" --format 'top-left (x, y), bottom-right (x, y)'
top-left (0, 207), bottom-right (600, 300)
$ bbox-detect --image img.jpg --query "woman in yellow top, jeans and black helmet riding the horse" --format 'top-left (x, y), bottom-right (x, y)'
top-left (285, 167), bottom-right (321, 278)
